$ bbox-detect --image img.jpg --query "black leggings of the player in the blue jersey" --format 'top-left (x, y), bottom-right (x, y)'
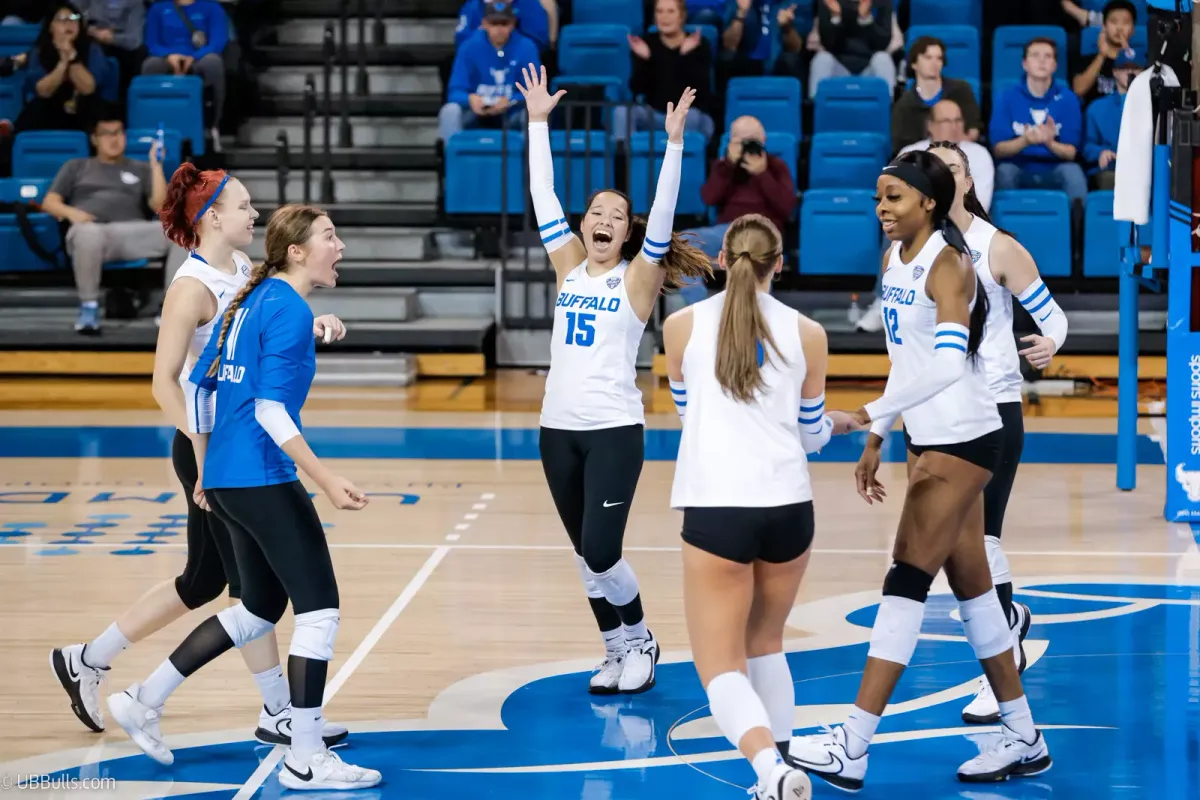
top-left (206, 481), bottom-right (338, 622)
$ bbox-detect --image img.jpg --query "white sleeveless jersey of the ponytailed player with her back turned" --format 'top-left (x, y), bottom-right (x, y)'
top-left (671, 291), bottom-right (812, 509)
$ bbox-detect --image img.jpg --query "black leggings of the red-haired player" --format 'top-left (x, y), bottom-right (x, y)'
top-left (170, 429), bottom-right (241, 609)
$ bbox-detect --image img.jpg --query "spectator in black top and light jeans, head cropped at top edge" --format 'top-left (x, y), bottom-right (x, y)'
top-left (809, 0), bottom-right (896, 97)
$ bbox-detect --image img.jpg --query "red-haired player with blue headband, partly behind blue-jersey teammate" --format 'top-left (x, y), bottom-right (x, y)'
top-left (50, 163), bottom-right (348, 745)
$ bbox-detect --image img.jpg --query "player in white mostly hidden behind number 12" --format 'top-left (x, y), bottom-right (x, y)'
top-left (929, 142), bottom-right (1067, 724)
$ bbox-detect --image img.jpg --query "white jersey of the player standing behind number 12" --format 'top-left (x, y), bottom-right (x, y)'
top-left (962, 217), bottom-right (1024, 403)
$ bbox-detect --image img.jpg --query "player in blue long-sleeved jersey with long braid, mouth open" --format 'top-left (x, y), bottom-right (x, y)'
top-left (108, 205), bottom-right (380, 789)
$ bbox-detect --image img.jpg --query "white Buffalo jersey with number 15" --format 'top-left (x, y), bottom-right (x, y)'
top-left (541, 261), bottom-right (646, 431)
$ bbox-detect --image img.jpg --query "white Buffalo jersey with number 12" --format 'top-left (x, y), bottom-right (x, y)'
top-left (881, 233), bottom-right (1001, 445)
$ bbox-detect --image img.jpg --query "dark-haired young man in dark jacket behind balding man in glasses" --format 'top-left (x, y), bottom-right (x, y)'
top-left (892, 36), bottom-right (990, 154)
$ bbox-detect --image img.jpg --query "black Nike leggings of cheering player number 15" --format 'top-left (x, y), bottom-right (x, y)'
top-left (538, 425), bottom-right (646, 573)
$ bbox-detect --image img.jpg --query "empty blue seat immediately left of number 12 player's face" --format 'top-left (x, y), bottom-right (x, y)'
top-left (799, 190), bottom-right (883, 275)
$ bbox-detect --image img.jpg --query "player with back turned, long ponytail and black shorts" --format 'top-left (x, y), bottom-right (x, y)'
top-left (662, 213), bottom-right (850, 800)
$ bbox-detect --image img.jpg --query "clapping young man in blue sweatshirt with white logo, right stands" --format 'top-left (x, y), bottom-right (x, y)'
top-left (989, 37), bottom-right (1087, 203)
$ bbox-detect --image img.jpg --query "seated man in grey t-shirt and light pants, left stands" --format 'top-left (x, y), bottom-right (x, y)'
top-left (42, 112), bottom-right (187, 333)
